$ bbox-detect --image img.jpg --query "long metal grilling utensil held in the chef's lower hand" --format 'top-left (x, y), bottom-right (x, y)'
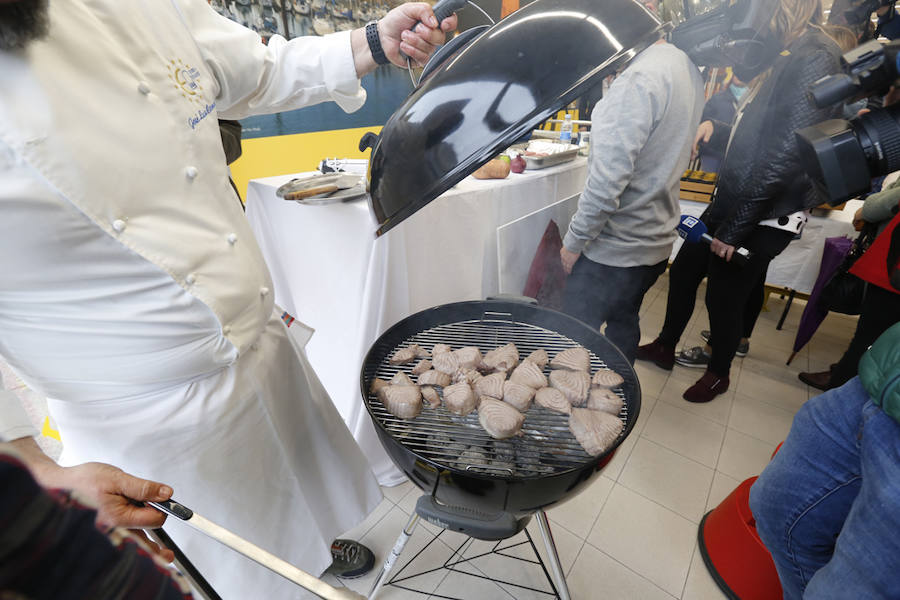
top-left (147, 500), bottom-right (365, 600)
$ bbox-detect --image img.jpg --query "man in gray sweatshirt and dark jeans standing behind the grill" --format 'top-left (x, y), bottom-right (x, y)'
top-left (560, 40), bottom-right (705, 363)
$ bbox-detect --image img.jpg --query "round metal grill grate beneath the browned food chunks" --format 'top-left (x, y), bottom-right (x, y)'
top-left (366, 313), bottom-right (628, 478)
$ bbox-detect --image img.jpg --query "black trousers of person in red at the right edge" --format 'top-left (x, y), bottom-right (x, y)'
top-left (829, 285), bottom-right (900, 387)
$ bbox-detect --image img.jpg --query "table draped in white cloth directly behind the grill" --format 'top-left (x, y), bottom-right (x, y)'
top-left (247, 157), bottom-right (587, 485)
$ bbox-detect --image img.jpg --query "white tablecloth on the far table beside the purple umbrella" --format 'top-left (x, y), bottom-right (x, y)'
top-left (672, 200), bottom-right (862, 294)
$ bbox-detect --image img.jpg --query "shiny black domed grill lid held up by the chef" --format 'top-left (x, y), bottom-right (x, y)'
top-left (367, 0), bottom-right (662, 235)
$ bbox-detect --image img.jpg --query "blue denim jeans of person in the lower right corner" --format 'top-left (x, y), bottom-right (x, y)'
top-left (750, 379), bottom-right (900, 600)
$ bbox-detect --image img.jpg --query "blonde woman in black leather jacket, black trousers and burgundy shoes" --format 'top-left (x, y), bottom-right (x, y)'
top-left (637, 7), bottom-right (841, 402)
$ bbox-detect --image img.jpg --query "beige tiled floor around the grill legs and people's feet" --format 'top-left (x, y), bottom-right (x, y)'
top-left (331, 276), bottom-right (855, 600)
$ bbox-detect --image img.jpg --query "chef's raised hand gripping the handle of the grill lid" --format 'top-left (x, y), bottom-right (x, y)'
top-left (378, 2), bottom-right (456, 67)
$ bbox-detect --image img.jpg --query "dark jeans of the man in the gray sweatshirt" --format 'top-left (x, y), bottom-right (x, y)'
top-left (563, 256), bottom-right (666, 364)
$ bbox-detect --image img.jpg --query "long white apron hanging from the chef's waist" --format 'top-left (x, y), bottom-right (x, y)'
top-left (49, 314), bottom-right (381, 599)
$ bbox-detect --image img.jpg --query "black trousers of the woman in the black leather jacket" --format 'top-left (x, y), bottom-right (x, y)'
top-left (659, 226), bottom-right (794, 377)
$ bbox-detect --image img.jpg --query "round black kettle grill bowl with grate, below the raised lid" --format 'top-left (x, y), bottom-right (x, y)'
top-left (360, 300), bottom-right (641, 516)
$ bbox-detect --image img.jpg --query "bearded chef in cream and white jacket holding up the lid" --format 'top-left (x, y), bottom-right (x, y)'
top-left (0, 0), bottom-right (456, 598)
